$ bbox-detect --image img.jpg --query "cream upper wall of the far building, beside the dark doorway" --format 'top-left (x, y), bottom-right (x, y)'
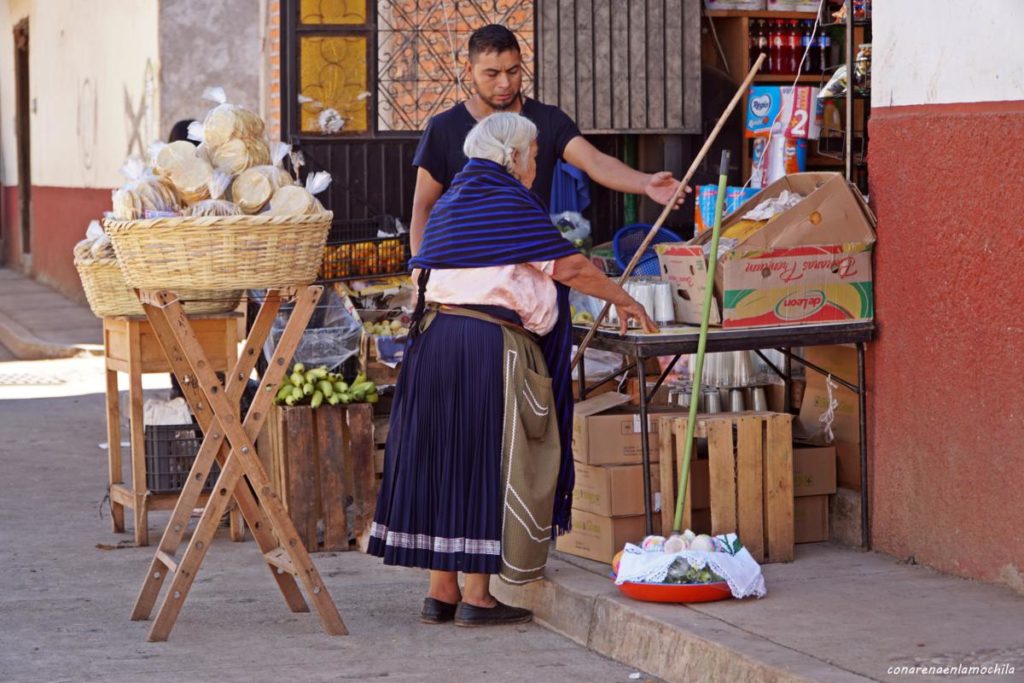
top-left (29, 0), bottom-right (160, 187)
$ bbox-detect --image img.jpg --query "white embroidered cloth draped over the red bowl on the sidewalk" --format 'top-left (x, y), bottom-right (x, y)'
top-left (615, 533), bottom-right (768, 598)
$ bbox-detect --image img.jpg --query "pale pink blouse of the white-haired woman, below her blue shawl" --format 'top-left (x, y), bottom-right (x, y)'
top-left (427, 261), bottom-right (558, 335)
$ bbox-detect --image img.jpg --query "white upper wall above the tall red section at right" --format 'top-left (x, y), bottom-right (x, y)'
top-left (871, 0), bottom-right (1024, 106)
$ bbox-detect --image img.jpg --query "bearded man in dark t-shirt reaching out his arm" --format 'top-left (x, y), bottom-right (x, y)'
top-left (410, 24), bottom-right (684, 254)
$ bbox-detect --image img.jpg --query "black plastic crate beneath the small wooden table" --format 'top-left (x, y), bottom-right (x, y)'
top-left (145, 425), bottom-right (220, 494)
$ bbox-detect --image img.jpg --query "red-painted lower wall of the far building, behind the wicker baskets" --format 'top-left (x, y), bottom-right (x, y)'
top-left (32, 185), bottom-right (111, 303)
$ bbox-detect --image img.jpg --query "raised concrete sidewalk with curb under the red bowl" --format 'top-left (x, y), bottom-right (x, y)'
top-left (493, 544), bottom-right (1024, 683)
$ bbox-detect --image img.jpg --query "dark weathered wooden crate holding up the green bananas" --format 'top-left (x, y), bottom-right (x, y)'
top-left (257, 403), bottom-right (377, 552)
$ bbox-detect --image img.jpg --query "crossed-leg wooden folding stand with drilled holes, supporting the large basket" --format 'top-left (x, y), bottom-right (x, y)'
top-left (131, 286), bottom-right (348, 641)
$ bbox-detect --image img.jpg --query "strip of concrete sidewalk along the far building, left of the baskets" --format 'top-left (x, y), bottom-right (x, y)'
top-left (0, 268), bottom-right (103, 360)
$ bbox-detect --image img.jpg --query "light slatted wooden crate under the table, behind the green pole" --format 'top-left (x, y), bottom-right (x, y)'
top-left (658, 413), bottom-right (794, 562)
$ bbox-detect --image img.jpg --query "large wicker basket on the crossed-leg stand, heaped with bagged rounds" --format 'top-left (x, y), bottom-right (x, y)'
top-left (103, 211), bottom-right (333, 290)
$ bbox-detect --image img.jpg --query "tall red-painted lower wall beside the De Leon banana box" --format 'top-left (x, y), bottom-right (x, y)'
top-left (868, 101), bottom-right (1024, 591)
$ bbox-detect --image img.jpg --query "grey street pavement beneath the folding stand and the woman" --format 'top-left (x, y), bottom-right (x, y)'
top-left (0, 357), bottom-right (656, 683)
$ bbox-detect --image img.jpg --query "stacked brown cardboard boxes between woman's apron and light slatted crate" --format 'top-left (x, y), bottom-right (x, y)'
top-left (556, 392), bottom-right (708, 562)
